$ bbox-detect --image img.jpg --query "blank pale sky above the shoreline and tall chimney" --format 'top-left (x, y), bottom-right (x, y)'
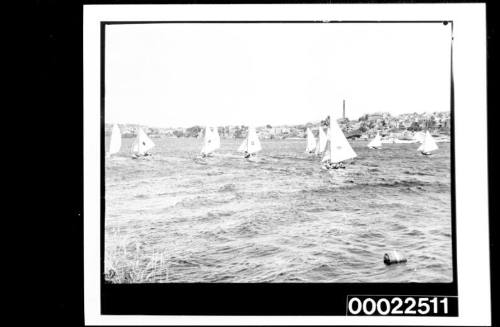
top-left (105, 23), bottom-right (451, 127)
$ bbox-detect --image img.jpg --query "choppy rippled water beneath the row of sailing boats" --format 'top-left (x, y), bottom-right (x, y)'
top-left (105, 138), bottom-right (453, 282)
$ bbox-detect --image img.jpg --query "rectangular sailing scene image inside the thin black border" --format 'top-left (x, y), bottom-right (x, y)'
top-left (104, 22), bottom-right (453, 283)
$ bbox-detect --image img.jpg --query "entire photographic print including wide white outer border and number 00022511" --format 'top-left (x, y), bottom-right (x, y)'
top-left (84, 5), bottom-right (489, 325)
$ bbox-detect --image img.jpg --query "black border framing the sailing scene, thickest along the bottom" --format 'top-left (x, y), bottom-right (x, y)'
top-left (100, 20), bottom-right (458, 316)
